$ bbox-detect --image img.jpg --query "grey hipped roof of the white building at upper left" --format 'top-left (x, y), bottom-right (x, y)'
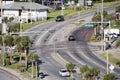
top-left (2, 2), bottom-right (50, 10)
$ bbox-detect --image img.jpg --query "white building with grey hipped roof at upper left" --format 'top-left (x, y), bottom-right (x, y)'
top-left (1, 2), bottom-right (50, 22)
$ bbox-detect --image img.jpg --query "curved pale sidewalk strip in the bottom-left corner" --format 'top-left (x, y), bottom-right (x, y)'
top-left (0, 66), bottom-right (28, 80)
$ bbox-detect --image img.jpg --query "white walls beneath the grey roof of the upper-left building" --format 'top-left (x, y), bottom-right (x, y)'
top-left (3, 10), bottom-right (47, 22)
